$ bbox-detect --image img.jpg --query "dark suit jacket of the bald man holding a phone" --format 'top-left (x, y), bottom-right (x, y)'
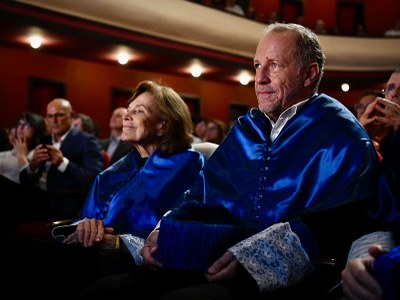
top-left (20, 128), bottom-right (104, 220)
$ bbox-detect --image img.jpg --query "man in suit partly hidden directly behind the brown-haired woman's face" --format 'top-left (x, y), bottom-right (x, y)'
top-left (100, 107), bottom-right (133, 164)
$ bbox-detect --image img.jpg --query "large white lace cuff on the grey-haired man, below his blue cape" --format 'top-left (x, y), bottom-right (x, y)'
top-left (229, 223), bottom-right (314, 292)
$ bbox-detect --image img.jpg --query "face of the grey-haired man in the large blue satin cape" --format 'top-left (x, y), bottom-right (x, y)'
top-left (254, 32), bottom-right (305, 121)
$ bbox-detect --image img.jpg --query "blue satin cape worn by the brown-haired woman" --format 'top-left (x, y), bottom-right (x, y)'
top-left (75, 147), bottom-right (205, 238)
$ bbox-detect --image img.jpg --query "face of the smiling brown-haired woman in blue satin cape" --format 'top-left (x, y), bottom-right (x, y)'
top-left (121, 92), bottom-right (164, 145)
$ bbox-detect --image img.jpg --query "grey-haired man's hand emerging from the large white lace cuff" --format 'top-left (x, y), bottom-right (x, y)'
top-left (205, 251), bottom-right (240, 282)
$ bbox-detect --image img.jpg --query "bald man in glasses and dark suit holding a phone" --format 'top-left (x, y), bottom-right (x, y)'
top-left (20, 98), bottom-right (104, 220)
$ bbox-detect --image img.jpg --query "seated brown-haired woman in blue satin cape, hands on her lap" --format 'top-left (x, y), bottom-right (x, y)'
top-left (5, 81), bottom-right (204, 297)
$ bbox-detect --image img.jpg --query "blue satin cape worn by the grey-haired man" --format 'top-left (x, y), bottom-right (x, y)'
top-left (189, 94), bottom-right (378, 241)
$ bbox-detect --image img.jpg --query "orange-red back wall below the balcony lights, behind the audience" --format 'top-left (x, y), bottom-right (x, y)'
top-left (0, 47), bottom-right (257, 137)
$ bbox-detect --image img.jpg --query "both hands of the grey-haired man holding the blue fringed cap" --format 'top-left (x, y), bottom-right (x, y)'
top-left (141, 230), bottom-right (240, 282)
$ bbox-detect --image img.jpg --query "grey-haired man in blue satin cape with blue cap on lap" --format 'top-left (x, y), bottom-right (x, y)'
top-left (81, 23), bottom-right (378, 299)
